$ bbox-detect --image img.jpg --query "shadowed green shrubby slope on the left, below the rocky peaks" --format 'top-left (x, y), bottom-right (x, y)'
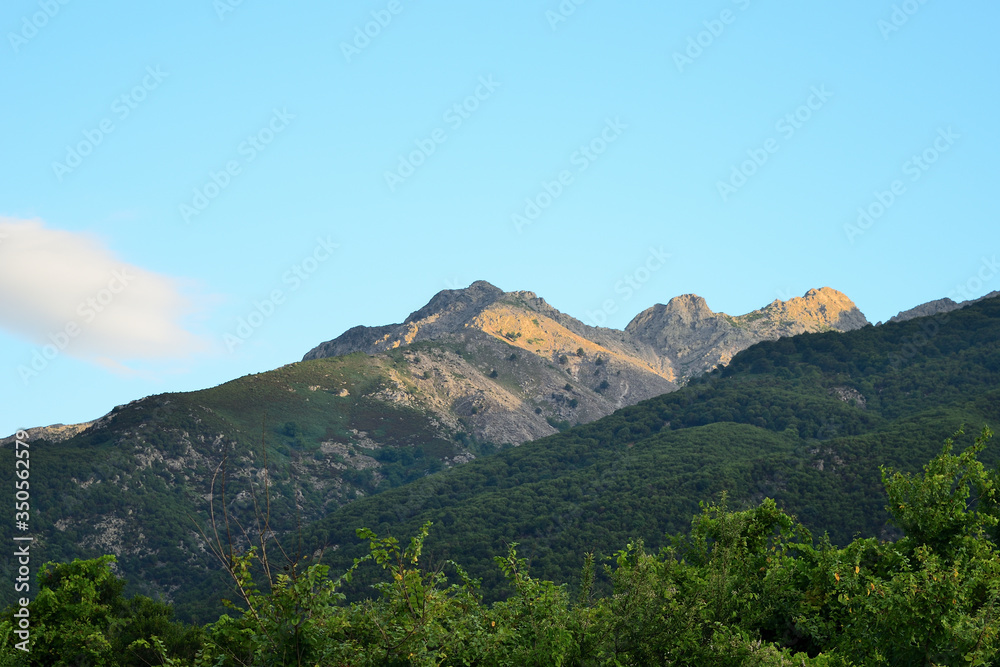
top-left (0, 353), bottom-right (468, 621)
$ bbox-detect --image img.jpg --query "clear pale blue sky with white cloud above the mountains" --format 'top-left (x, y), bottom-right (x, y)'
top-left (0, 0), bottom-right (1000, 435)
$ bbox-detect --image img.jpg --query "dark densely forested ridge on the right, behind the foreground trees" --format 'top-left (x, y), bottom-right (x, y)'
top-left (304, 298), bottom-right (1000, 599)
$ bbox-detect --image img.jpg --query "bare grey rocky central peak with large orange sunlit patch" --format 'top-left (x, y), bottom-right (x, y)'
top-left (303, 282), bottom-right (679, 444)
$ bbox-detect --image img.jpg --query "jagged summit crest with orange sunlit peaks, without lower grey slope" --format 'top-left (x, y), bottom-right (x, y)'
top-left (303, 280), bottom-right (868, 386)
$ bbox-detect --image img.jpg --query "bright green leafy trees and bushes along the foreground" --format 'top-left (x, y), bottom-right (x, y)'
top-left (0, 428), bottom-right (1000, 667)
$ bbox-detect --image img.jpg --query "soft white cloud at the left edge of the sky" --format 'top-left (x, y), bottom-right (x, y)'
top-left (0, 217), bottom-right (206, 367)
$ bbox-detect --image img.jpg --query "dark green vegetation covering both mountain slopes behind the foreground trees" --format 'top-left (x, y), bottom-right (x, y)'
top-left (0, 299), bottom-right (1000, 623)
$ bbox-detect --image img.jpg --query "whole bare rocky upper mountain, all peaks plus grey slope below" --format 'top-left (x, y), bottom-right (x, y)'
top-left (303, 281), bottom-right (868, 443)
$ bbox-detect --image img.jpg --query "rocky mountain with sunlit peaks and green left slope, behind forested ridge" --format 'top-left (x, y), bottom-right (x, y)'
top-left (0, 282), bottom-right (865, 618)
